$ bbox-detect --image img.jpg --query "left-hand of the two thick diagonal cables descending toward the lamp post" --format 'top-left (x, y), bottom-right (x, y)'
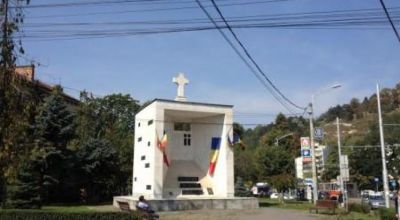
top-left (196, 0), bottom-right (293, 113)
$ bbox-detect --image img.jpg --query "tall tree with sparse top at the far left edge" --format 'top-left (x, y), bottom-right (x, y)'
top-left (0, 0), bottom-right (32, 182)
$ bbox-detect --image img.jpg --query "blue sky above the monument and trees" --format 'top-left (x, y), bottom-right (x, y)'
top-left (14, 0), bottom-right (400, 124)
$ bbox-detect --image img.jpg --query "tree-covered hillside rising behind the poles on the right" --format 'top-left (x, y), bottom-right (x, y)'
top-left (317, 83), bottom-right (400, 145)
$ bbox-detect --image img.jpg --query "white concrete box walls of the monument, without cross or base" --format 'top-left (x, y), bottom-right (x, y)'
top-left (133, 101), bottom-right (234, 199)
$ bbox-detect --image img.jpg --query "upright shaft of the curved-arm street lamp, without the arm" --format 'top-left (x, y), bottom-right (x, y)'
top-left (308, 99), bottom-right (318, 204)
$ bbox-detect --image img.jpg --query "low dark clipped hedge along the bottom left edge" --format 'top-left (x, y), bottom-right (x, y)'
top-left (0, 210), bottom-right (139, 220)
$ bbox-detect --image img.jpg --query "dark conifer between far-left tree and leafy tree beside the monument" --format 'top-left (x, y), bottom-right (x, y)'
top-left (6, 87), bottom-right (74, 208)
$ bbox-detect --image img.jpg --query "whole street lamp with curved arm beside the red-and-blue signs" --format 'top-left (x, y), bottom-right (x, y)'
top-left (308, 84), bottom-right (341, 204)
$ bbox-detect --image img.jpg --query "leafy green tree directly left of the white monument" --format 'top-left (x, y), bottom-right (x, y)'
top-left (76, 93), bottom-right (140, 194)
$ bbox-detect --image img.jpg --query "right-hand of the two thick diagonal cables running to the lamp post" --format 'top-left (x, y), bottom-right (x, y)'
top-left (211, 0), bottom-right (305, 110)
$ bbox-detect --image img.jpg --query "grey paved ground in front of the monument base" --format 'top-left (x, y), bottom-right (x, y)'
top-left (159, 208), bottom-right (319, 220)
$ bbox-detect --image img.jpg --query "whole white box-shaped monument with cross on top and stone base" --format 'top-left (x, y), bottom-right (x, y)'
top-left (114, 73), bottom-right (258, 210)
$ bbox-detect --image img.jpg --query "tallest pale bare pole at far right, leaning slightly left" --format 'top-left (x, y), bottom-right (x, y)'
top-left (376, 84), bottom-right (389, 208)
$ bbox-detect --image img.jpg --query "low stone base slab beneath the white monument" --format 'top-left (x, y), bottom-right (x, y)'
top-left (113, 196), bottom-right (258, 211)
